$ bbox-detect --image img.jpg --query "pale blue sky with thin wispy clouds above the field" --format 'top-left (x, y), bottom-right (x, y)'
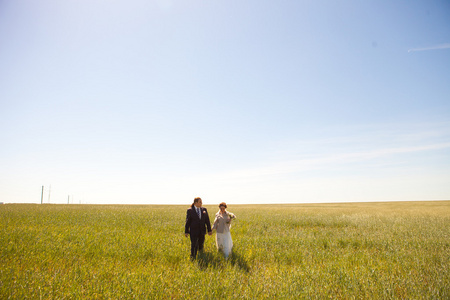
top-left (0, 0), bottom-right (450, 204)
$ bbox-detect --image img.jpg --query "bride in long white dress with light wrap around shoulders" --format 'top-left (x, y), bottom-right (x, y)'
top-left (212, 202), bottom-right (236, 257)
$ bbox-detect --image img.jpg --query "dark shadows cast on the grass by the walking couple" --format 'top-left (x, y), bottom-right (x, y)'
top-left (196, 251), bottom-right (250, 273)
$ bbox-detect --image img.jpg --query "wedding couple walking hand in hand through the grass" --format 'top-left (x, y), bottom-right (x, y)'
top-left (184, 197), bottom-right (236, 259)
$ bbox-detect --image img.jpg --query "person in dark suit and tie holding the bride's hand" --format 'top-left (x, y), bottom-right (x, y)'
top-left (184, 197), bottom-right (212, 259)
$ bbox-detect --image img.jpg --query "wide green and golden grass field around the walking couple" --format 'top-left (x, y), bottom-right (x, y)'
top-left (0, 201), bottom-right (450, 299)
